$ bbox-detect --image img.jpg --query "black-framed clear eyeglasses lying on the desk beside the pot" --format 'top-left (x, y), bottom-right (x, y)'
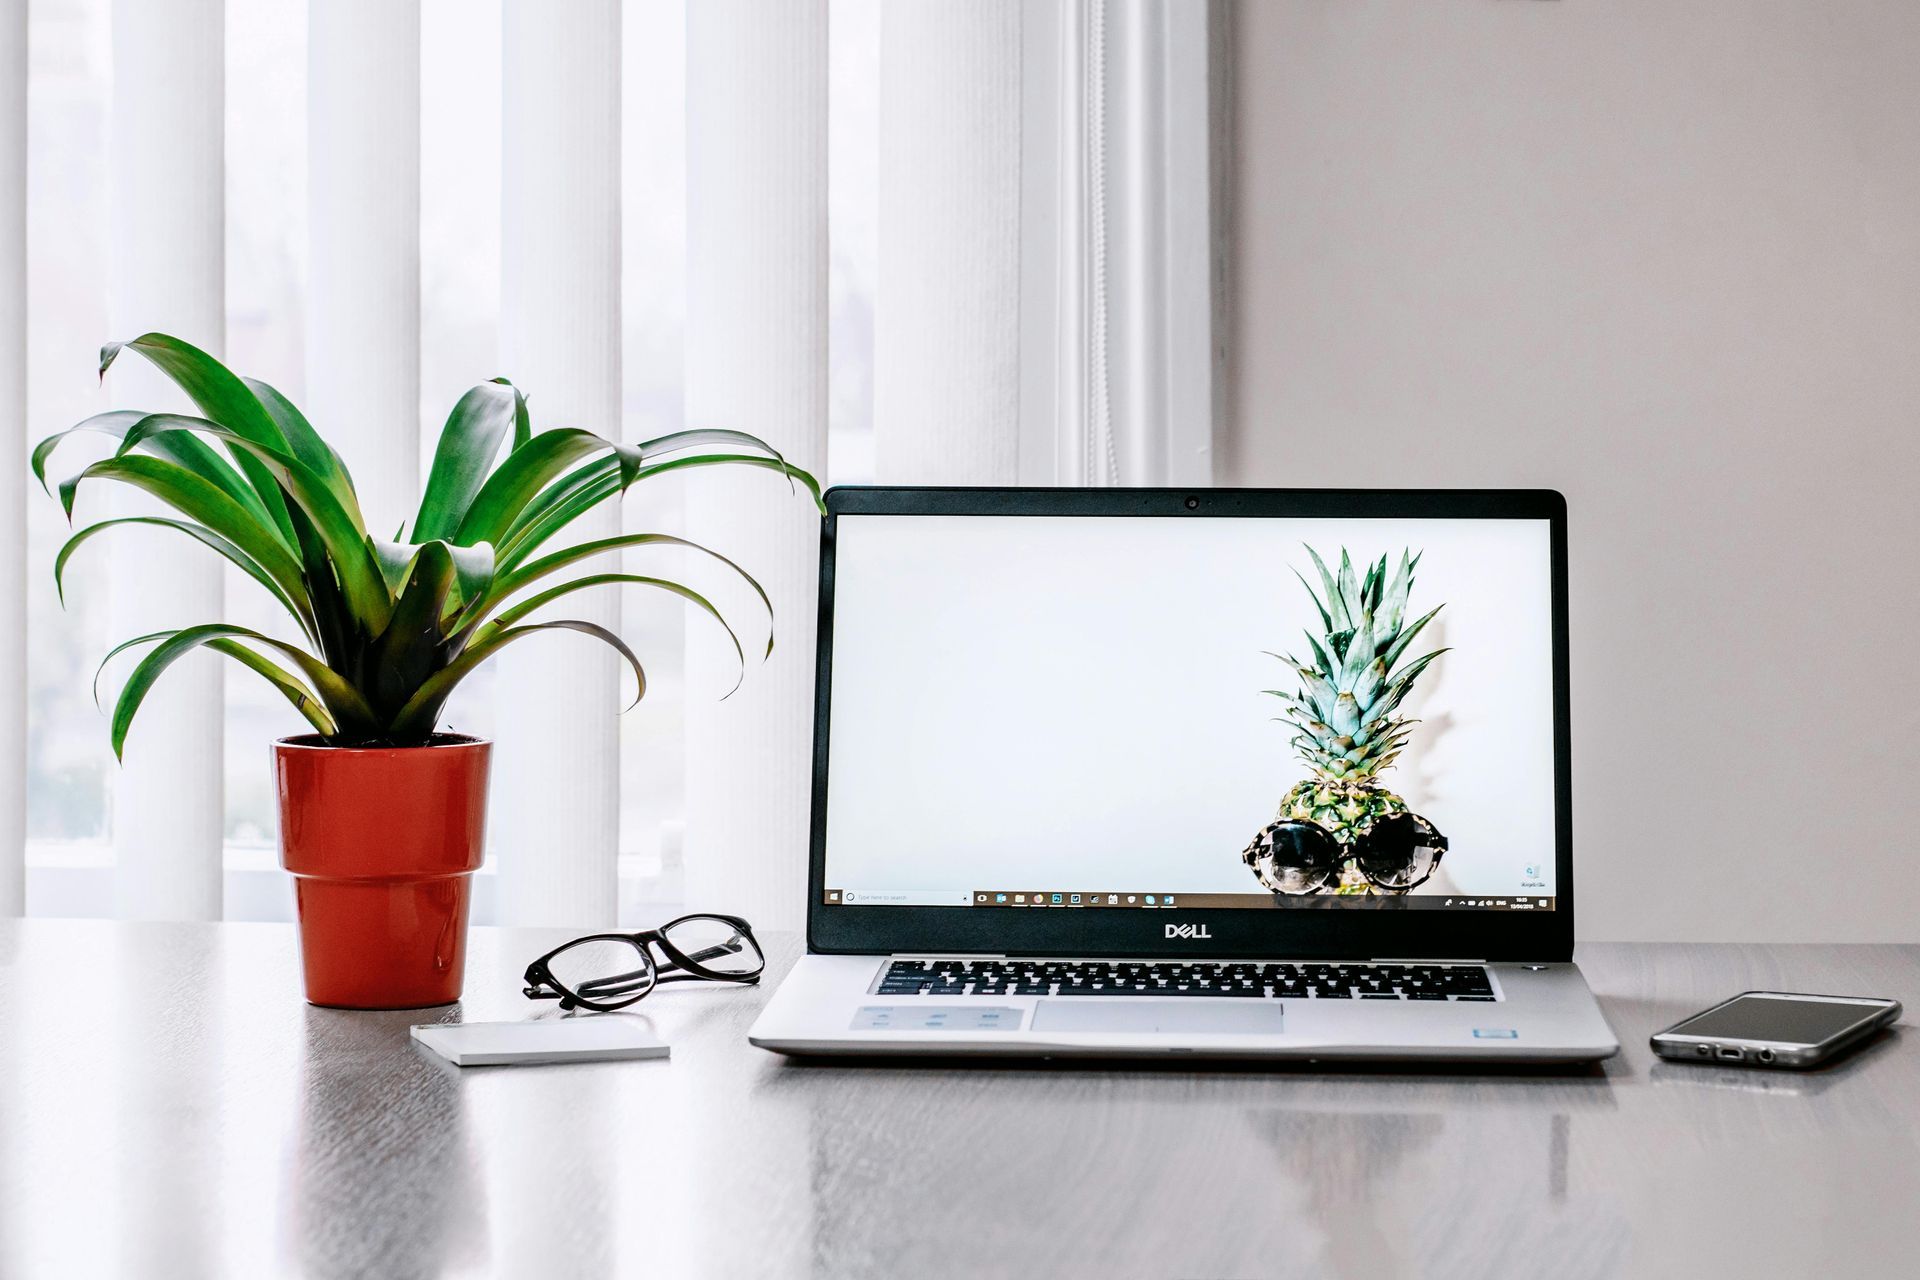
top-left (522, 915), bottom-right (766, 1013)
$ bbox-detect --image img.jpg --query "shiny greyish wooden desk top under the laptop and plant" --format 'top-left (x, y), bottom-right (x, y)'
top-left (0, 921), bottom-right (1920, 1280)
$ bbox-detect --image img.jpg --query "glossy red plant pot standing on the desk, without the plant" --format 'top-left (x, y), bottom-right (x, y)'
top-left (273, 733), bottom-right (492, 1009)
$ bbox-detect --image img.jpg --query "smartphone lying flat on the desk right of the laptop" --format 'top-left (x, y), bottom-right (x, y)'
top-left (1651, 990), bottom-right (1901, 1071)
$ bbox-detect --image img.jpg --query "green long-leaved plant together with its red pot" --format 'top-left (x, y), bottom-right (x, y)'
top-left (33, 334), bottom-right (820, 1009)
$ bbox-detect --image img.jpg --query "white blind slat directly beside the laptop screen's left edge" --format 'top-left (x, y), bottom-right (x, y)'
top-left (685, 0), bottom-right (828, 929)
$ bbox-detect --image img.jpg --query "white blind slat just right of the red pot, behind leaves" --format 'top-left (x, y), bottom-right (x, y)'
top-left (493, 0), bottom-right (632, 929)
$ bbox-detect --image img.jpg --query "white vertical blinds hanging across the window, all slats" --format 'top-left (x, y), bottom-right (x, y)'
top-left (0, 0), bottom-right (1213, 927)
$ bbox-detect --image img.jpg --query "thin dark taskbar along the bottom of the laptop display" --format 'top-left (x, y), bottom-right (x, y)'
top-left (822, 889), bottom-right (1555, 912)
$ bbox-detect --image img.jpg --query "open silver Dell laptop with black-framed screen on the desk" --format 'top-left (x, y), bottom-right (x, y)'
top-left (751, 487), bottom-right (1619, 1063)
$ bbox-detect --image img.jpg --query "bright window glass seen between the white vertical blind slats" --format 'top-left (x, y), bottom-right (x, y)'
top-left (27, 0), bottom-right (879, 923)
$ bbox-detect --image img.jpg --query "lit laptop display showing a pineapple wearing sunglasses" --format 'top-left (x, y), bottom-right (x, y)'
top-left (822, 514), bottom-right (1555, 913)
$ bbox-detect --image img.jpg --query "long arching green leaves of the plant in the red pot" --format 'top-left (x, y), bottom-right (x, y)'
top-left (56, 334), bottom-right (821, 754)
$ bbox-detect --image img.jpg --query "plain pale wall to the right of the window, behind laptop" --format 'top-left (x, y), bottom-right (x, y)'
top-left (1225, 0), bottom-right (1920, 942)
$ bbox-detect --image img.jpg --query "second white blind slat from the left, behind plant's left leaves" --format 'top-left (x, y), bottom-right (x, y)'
top-left (108, 0), bottom-right (227, 919)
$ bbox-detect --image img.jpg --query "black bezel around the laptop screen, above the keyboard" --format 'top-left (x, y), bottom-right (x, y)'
top-left (806, 486), bottom-right (1574, 960)
